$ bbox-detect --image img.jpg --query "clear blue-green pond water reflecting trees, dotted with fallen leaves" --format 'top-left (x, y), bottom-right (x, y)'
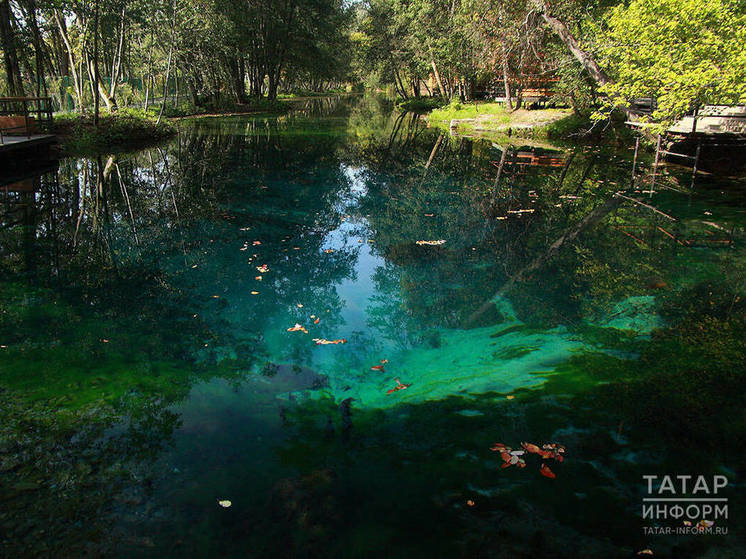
top-left (0, 97), bottom-right (746, 558)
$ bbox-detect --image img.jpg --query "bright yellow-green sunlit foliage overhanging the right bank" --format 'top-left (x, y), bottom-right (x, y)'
top-left (599, 0), bottom-right (746, 125)
